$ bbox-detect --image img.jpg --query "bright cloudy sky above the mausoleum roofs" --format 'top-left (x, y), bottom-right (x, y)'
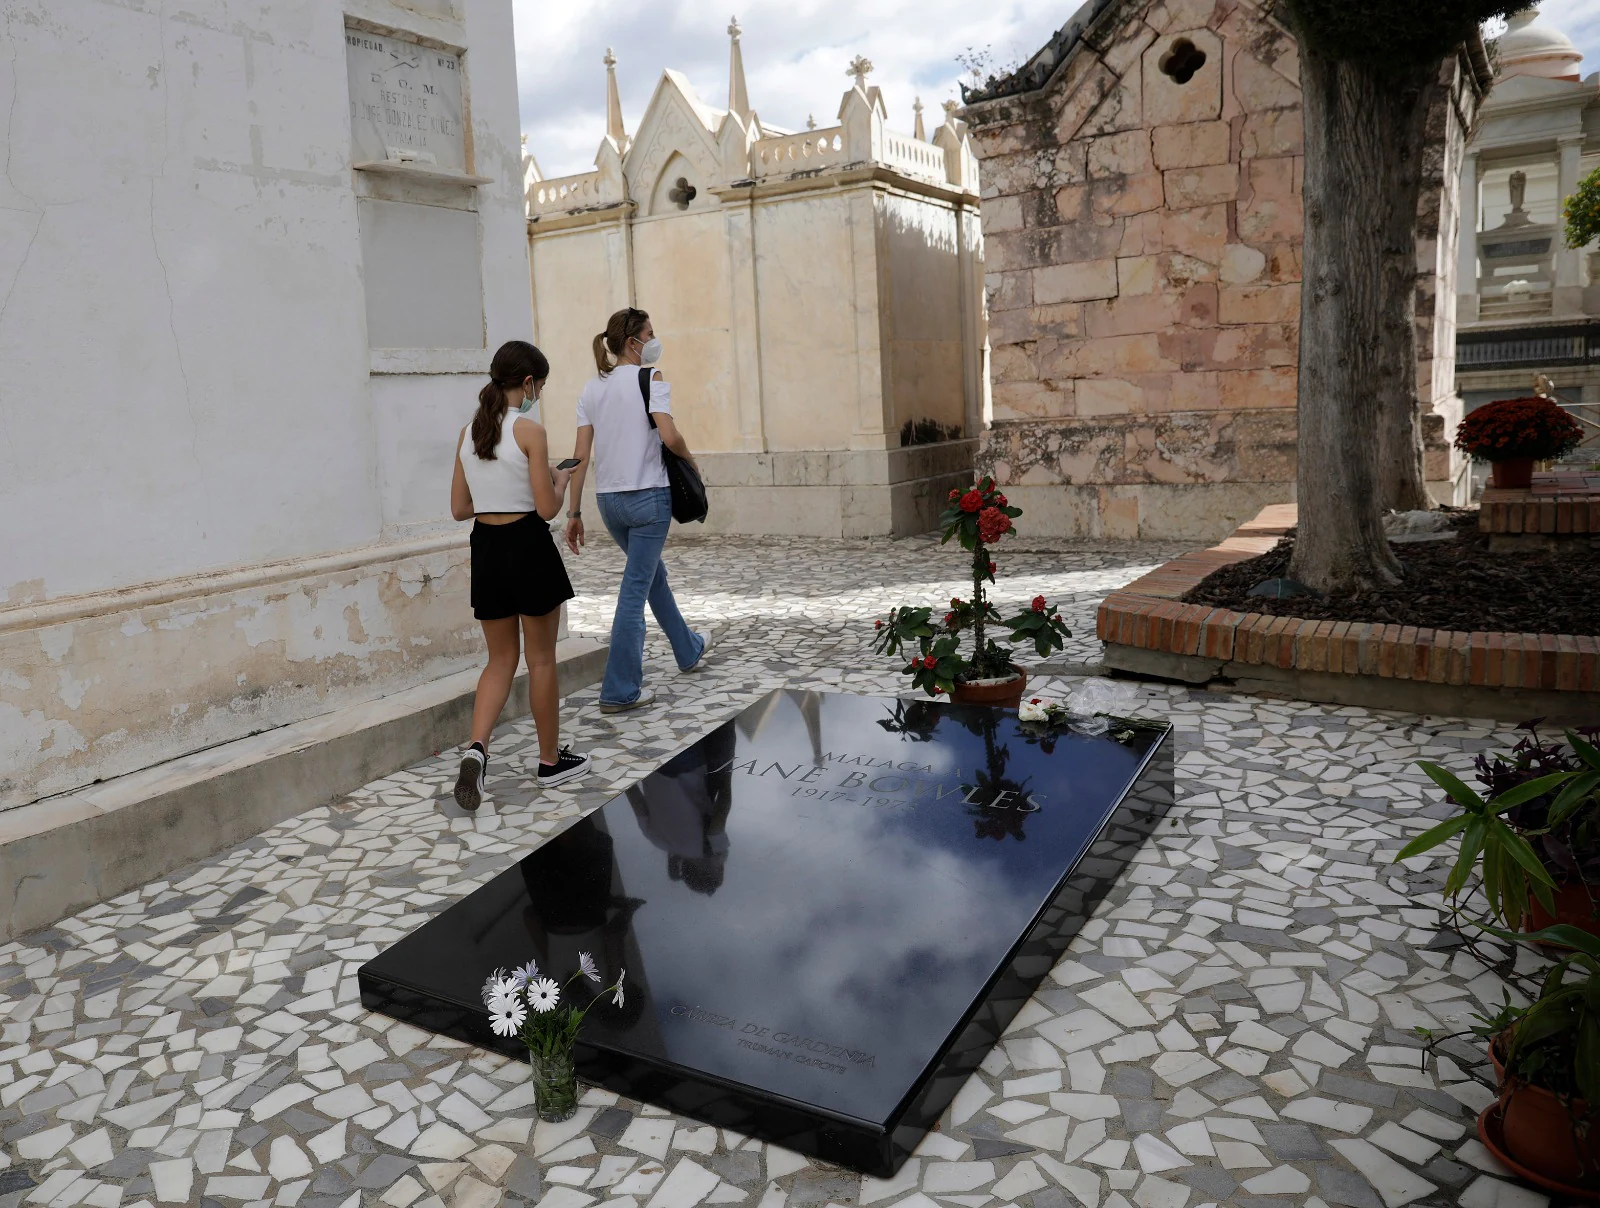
top-left (512, 0), bottom-right (1600, 176)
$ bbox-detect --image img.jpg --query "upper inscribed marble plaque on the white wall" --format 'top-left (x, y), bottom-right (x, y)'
top-left (344, 29), bottom-right (467, 171)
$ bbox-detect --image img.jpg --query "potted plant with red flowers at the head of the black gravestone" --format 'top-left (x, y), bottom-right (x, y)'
top-left (874, 477), bottom-right (1072, 706)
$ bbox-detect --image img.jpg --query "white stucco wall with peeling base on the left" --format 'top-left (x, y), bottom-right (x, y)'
top-left (0, 0), bottom-right (531, 806)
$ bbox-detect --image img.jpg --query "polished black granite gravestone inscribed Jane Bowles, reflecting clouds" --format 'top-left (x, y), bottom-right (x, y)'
top-left (360, 691), bottom-right (1173, 1176)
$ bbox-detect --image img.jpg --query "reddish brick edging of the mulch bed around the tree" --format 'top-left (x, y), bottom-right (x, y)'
top-left (1094, 504), bottom-right (1600, 693)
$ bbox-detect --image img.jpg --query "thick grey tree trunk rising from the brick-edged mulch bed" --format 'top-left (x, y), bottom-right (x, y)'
top-left (1290, 43), bottom-right (1438, 592)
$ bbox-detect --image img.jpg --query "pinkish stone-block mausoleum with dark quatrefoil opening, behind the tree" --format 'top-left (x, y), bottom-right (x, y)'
top-left (963, 0), bottom-right (1488, 539)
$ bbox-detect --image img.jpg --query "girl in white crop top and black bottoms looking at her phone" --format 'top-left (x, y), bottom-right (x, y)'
top-left (450, 339), bottom-right (589, 810)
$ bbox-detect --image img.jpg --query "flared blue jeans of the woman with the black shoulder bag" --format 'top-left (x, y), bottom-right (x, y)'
top-left (595, 486), bottom-right (706, 704)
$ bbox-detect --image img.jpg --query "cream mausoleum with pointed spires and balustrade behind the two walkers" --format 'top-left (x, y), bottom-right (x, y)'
top-left (526, 24), bottom-right (987, 536)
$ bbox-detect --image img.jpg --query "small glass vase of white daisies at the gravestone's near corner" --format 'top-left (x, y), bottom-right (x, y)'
top-left (483, 952), bottom-right (627, 1123)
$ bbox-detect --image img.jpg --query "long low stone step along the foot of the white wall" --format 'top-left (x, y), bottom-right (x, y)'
top-left (0, 637), bottom-right (606, 941)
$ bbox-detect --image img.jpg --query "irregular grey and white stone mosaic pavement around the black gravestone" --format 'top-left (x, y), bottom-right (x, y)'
top-left (0, 539), bottom-right (1547, 1208)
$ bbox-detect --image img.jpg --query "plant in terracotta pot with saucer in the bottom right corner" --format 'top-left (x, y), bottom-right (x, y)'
top-left (1470, 926), bottom-right (1600, 1200)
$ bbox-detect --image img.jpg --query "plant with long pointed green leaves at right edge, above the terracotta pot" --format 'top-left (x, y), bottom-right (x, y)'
top-left (1395, 725), bottom-right (1600, 934)
